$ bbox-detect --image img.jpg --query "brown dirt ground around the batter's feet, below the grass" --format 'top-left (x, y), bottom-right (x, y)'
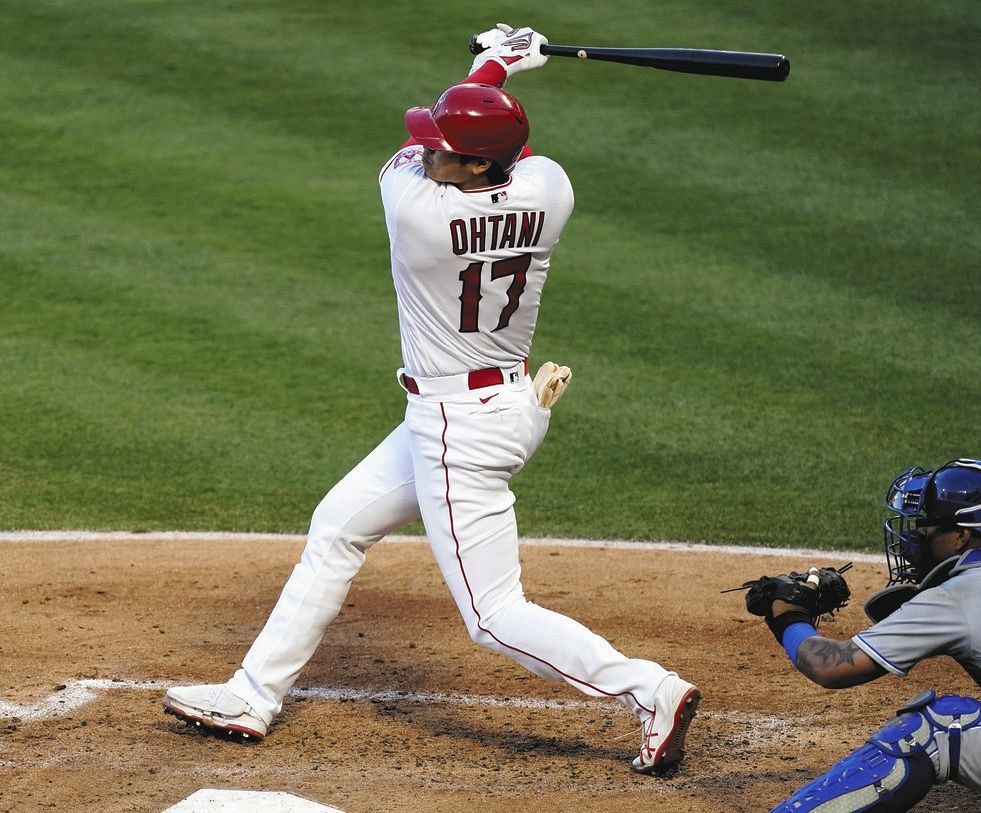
top-left (0, 540), bottom-right (977, 813)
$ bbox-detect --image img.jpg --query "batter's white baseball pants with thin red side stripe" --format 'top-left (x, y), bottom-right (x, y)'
top-left (228, 365), bottom-right (669, 723)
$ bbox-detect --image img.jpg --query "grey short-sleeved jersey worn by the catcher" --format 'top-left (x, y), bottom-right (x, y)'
top-left (852, 548), bottom-right (981, 686)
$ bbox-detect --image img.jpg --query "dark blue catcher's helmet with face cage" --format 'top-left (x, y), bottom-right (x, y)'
top-left (883, 457), bottom-right (981, 584)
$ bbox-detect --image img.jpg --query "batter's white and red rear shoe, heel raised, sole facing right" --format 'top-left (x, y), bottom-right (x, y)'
top-left (633, 675), bottom-right (702, 778)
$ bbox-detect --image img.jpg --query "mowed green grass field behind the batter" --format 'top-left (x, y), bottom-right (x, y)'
top-left (0, 0), bottom-right (981, 547)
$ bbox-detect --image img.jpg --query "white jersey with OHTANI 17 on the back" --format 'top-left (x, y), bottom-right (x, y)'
top-left (378, 145), bottom-right (573, 377)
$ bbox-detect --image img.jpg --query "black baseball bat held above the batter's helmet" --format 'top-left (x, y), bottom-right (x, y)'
top-left (470, 34), bottom-right (790, 82)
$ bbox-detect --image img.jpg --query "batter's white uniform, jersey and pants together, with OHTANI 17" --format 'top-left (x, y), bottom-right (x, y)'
top-left (228, 136), bottom-right (673, 723)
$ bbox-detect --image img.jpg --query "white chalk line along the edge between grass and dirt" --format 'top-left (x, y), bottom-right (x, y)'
top-left (0, 531), bottom-right (884, 564)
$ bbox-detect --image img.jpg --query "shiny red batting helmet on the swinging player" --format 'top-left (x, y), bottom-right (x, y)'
top-left (405, 85), bottom-right (530, 172)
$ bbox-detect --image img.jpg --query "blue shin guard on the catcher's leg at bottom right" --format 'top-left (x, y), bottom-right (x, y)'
top-left (770, 690), bottom-right (981, 813)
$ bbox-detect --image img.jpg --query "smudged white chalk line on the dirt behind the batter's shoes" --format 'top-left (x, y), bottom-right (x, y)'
top-left (0, 678), bottom-right (801, 732)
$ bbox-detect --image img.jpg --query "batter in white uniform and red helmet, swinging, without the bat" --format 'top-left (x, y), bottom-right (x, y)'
top-left (164, 25), bottom-right (700, 775)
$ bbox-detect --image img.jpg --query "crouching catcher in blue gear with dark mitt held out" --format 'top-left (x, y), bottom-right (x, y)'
top-left (737, 458), bottom-right (981, 813)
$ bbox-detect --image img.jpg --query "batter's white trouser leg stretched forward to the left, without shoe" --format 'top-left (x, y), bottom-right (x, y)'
top-left (220, 424), bottom-right (419, 723)
